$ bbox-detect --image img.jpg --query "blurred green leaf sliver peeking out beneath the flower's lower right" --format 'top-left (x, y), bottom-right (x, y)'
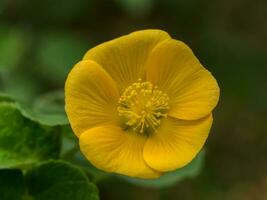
top-left (122, 151), bottom-right (205, 188)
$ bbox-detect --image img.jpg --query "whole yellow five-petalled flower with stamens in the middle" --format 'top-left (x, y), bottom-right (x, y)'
top-left (65, 30), bottom-right (219, 179)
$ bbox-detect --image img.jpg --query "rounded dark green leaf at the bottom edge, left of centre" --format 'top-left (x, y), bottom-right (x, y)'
top-left (26, 161), bottom-right (99, 200)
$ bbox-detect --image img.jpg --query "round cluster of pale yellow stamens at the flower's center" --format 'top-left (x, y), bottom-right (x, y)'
top-left (118, 79), bottom-right (169, 134)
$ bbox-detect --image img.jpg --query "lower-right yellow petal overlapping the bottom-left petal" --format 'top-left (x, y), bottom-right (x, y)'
top-left (144, 115), bottom-right (212, 172)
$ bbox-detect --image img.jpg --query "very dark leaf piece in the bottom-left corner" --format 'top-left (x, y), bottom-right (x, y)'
top-left (0, 170), bottom-right (25, 200)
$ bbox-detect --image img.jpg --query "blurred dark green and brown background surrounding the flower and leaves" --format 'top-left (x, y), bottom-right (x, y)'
top-left (0, 0), bottom-right (267, 200)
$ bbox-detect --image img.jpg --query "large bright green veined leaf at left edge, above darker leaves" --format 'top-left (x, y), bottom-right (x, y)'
top-left (0, 102), bottom-right (60, 169)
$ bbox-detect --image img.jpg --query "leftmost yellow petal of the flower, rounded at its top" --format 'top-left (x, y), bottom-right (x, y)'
top-left (65, 60), bottom-right (119, 136)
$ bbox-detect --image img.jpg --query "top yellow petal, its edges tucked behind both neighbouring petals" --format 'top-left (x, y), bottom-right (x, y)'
top-left (84, 30), bottom-right (170, 90)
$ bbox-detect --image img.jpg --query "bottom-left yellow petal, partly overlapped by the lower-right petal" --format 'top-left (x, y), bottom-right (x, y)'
top-left (80, 125), bottom-right (160, 178)
